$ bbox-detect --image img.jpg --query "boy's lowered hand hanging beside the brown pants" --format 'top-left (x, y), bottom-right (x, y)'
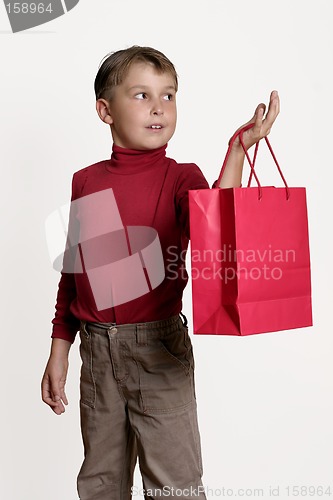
top-left (41, 354), bottom-right (68, 415)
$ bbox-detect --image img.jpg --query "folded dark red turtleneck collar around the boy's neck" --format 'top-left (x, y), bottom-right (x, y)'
top-left (106, 144), bottom-right (167, 175)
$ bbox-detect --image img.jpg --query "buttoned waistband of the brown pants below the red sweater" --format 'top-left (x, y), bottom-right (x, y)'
top-left (80, 313), bottom-right (187, 338)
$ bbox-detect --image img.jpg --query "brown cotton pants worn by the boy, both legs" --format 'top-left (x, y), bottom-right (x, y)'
top-left (77, 314), bottom-right (206, 500)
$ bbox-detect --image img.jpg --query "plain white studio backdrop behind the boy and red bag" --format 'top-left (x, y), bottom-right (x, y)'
top-left (0, 0), bottom-right (333, 500)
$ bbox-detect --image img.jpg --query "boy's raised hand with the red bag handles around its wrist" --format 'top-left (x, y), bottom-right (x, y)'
top-left (233, 90), bottom-right (280, 152)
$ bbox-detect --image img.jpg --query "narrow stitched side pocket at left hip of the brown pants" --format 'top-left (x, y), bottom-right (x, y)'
top-left (80, 327), bottom-right (96, 408)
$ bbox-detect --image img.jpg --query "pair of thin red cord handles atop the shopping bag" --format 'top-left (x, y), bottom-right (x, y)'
top-left (217, 123), bottom-right (290, 200)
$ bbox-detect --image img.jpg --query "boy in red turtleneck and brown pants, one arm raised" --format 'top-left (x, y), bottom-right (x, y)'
top-left (42, 46), bottom-right (279, 500)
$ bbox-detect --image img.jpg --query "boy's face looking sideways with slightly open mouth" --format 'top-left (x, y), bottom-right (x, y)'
top-left (104, 62), bottom-right (177, 150)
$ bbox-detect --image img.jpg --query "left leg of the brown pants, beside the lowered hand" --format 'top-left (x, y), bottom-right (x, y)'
top-left (77, 329), bottom-right (137, 500)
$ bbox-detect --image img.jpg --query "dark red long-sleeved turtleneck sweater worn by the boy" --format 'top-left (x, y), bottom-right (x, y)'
top-left (52, 145), bottom-right (215, 342)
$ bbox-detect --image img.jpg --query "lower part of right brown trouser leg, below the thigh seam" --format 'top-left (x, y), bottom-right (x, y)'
top-left (131, 402), bottom-right (206, 500)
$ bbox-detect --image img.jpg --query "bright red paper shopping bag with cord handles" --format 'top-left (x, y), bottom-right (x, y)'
top-left (189, 124), bottom-right (312, 335)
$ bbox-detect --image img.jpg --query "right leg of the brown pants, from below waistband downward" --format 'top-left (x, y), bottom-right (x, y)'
top-left (128, 314), bottom-right (206, 500)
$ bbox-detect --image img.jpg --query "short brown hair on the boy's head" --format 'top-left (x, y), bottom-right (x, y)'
top-left (94, 45), bottom-right (178, 100)
